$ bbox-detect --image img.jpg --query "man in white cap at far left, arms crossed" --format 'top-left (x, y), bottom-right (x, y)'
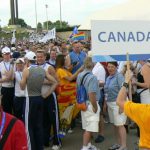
top-left (0, 47), bottom-right (14, 114)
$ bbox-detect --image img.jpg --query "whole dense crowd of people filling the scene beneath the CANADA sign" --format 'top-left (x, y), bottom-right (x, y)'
top-left (0, 41), bottom-right (150, 150)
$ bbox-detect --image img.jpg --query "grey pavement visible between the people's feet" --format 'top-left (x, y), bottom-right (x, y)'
top-left (45, 124), bottom-right (137, 150)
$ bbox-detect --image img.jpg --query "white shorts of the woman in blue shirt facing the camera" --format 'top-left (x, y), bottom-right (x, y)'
top-left (107, 102), bottom-right (127, 126)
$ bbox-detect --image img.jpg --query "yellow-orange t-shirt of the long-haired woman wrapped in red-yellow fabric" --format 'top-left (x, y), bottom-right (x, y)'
top-left (56, 68), bottom-right (72, 85)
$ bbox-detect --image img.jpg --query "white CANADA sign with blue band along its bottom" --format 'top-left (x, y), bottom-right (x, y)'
top-left (91, 20), bottom-right (150, 61)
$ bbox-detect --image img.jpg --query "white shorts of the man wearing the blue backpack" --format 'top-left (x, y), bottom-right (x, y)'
top-left (81, 103), bottom-right (100, 132)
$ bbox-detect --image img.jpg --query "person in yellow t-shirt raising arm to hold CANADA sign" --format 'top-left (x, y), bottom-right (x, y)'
top-left (117, 72), bottom-right (150, 150)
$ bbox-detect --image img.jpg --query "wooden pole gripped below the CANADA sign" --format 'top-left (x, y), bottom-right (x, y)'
top-left (126, 52), bottom-right (132, 101)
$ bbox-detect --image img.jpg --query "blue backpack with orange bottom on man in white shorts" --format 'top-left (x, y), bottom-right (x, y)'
top-left (77, 72), bottom-right (90, 111)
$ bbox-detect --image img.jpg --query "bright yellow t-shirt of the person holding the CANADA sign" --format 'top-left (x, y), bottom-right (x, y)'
top-left (124, 101), bottom-right (150, 148)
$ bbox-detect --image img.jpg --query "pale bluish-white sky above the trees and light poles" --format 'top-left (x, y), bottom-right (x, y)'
top-left (0, 0), bottom-right (126, 27)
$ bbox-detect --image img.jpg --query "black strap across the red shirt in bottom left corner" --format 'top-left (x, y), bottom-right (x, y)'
top-left (0, 118), bottom-right (17, 149)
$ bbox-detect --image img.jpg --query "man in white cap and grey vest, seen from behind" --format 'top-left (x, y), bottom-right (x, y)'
top-left (20, 51), bottom-right (57, 150)
